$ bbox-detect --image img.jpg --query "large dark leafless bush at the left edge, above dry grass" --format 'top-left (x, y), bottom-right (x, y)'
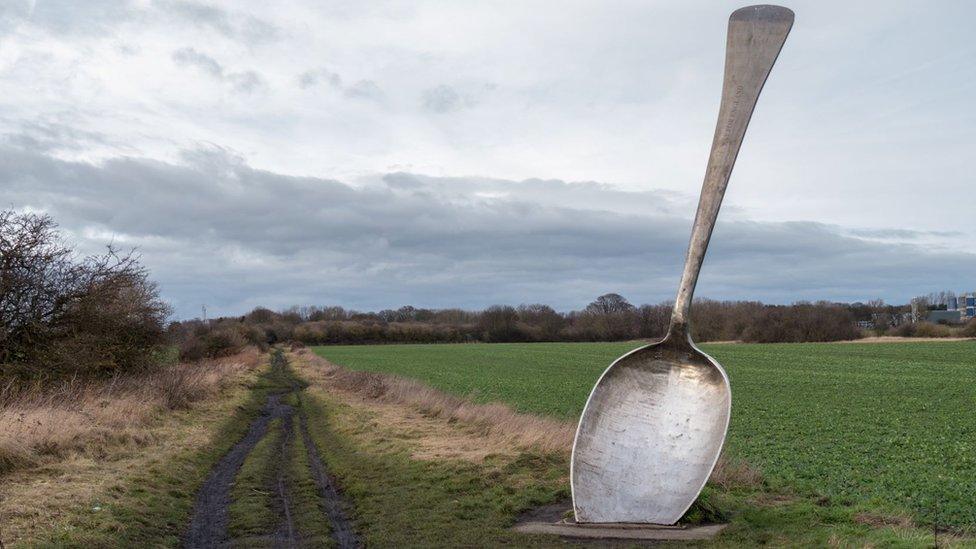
top-left (0, 210), bottom-right (169, 375)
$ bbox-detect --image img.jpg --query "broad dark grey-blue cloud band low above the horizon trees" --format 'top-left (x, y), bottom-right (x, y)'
top-left (0, 146), bottom-right (976, 315)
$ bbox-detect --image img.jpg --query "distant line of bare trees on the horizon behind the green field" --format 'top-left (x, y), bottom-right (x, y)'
top-left (170, 293), bottom-right (887, 358)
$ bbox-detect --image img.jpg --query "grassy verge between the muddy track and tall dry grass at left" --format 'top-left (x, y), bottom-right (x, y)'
top-left (0, 354), bottom-right (276, 547)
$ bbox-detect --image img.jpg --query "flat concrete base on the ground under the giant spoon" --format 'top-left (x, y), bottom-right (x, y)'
top-left (515, 520), bottom-right (728, 541)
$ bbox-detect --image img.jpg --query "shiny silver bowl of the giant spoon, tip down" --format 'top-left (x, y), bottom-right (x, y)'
top-left (570, 328), bottom-right (732, 524)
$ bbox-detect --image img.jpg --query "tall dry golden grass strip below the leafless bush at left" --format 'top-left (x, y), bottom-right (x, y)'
top-left (0, 351), bottom-right (259, 475)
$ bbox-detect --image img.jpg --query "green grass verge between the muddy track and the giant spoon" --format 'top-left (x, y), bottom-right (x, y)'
top-left (303, 388), bottom-right (568, 547)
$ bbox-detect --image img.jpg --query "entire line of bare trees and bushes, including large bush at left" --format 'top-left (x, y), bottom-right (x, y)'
top-left (0, 210), bottom-right (976, 375)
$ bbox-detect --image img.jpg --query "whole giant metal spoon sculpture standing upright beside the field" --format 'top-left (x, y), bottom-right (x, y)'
top-left (570, 6), bottom-right (793, 524)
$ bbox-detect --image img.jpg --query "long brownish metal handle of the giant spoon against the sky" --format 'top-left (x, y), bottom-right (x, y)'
top-left (671, 5), bottom-right (793, 332)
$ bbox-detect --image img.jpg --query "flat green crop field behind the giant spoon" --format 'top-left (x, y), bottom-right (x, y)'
top-left (315, 341), bottom-right (976, 532)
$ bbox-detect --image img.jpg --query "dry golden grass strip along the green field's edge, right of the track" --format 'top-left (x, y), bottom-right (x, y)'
top-left (292, 349), bottom-right (763, 490)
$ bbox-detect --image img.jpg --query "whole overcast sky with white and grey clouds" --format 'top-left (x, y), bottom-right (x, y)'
top-left (0, 0), bottom-right (976, 317)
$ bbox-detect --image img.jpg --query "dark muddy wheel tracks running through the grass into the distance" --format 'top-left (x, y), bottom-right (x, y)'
top-left (183, 351), bottom-right (362, 549)
